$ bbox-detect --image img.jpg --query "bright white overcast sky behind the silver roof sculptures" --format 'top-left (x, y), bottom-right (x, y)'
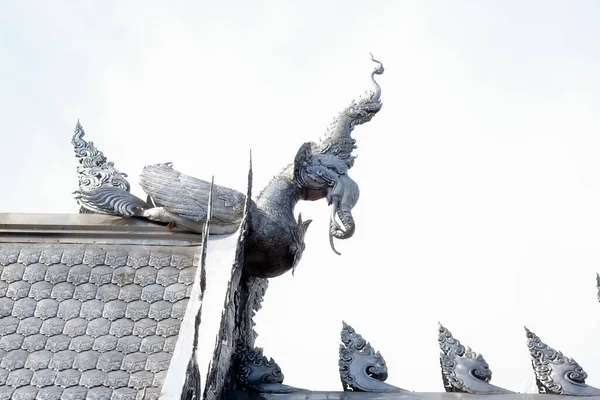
top-left (0, 0), bottom-right (600, 392)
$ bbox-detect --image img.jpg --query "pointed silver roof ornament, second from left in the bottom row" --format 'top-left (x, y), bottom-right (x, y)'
top-left (339, 322), bottom-right (408, 393)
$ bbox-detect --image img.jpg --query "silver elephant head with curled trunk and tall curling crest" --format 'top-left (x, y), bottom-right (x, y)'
top-left (294, 55), bottom-right (384, 254)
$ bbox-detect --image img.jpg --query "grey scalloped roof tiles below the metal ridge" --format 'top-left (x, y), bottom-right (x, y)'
top-left (0, 243), bottom-right (199, 400)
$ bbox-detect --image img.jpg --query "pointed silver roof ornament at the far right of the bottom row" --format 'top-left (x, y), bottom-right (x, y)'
top-left (525, 327), bottom-right (600, 396)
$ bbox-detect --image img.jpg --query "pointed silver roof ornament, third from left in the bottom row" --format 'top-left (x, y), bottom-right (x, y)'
top-left (438, 324), bottom-right (512, 394)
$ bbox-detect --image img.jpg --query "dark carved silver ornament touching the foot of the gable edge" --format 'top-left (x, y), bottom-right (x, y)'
top-left (233, 341), bottom-right (302, 393)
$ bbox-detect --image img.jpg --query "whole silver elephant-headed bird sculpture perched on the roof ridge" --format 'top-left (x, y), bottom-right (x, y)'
top-left (74, 56), bottom-right (384, 278)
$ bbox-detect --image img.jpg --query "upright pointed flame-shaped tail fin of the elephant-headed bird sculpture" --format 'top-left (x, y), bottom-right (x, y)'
top-left (71, 121), bottom-right (130, 214)
